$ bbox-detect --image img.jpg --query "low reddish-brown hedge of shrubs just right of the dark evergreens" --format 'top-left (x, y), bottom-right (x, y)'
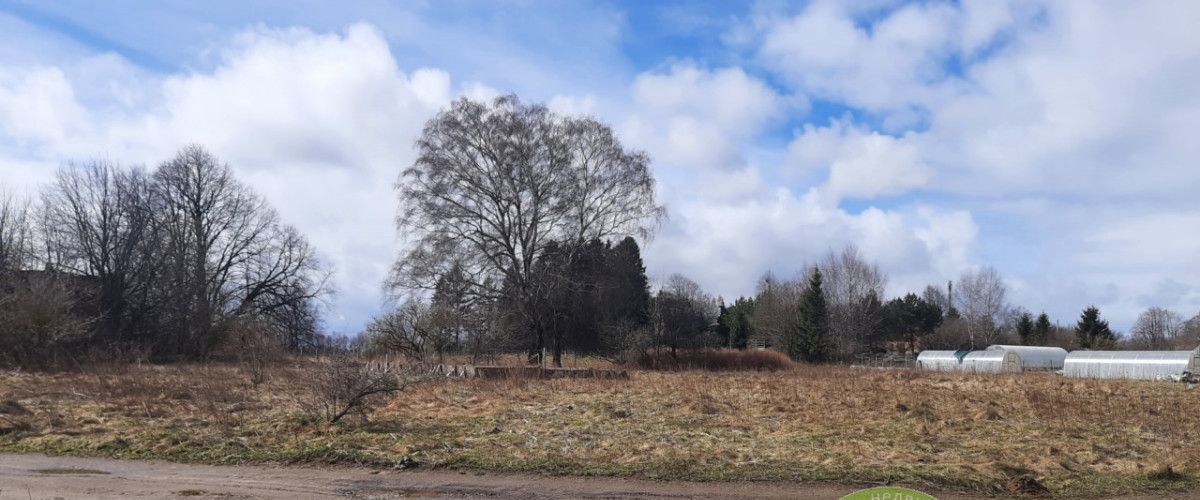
top-left (637, 349), bottom-right (796, 372)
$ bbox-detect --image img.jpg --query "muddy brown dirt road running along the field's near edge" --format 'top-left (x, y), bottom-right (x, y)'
top-left (0, 454), bottom-right (1187, 500)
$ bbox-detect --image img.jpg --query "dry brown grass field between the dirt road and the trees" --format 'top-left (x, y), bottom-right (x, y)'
top-left (0, 361), bottom-right (1200, 496)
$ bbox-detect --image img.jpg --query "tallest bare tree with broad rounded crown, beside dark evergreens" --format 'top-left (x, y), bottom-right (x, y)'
top-left (390, 96), bottom-right (664, 362)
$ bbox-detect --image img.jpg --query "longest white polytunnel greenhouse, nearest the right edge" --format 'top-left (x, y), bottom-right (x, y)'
top-left (1062, 349), bottom-right (1200, 380)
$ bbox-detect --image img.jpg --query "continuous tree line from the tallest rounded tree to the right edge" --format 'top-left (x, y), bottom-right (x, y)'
top-left (367, 96), bottom-right (1200, 365)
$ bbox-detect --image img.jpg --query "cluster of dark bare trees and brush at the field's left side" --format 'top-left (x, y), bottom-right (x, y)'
top-left (0, 146), bottom-right (328, 365)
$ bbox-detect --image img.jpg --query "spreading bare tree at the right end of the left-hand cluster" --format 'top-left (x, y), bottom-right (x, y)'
top-left (154, 146), bottom-right (325, 355)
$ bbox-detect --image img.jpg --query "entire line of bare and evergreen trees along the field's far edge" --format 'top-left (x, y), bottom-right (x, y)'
top-left (0, 96), bottom-right (1200, 365)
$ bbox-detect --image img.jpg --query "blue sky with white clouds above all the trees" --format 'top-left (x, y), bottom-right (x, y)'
top-left (0, 0), bottom-right (1200, 333)
